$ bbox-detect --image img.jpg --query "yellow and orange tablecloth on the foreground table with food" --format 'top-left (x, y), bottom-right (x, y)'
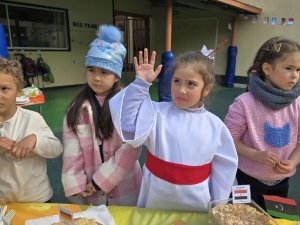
top-left (7, 203), bottom-right (300, 225)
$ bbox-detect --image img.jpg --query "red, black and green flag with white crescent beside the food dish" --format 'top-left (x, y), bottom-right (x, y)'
top-left (263, 195), bottom-right (299, 221)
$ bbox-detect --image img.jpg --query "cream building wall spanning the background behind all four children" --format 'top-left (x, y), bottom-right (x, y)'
top-left (5, 0), bottom-right (300, 87)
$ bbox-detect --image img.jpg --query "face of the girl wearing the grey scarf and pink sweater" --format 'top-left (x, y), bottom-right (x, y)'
top-left (262, 52), bottom-right (300, 91)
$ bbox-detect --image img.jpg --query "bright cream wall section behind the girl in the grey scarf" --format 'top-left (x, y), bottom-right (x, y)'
top-left (236, 0), bottom-right (300, 76)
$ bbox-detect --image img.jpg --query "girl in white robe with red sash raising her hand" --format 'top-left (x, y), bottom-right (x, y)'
top-left (110, 49), bottom-right (238, 211)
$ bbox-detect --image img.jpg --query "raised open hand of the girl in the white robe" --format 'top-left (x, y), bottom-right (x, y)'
top-left (133, 48), bottom-right (162, 83)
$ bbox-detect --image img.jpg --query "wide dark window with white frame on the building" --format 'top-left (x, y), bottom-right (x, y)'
top-left (0, 3), bottom-right (70, 50)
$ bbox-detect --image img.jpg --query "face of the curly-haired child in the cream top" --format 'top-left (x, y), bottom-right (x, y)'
top-left (0, 72), bottom-right (22, 121)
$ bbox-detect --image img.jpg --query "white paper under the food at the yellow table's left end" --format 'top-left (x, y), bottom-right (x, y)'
top-left (25, 205), bottom-right (116, 225)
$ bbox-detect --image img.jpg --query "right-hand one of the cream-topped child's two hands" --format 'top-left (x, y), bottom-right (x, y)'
top-left (11, 134), bottom-right (36, 159)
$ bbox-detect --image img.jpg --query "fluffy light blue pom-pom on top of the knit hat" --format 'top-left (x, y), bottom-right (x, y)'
top-left (97, 25), bottom-right (121, 43)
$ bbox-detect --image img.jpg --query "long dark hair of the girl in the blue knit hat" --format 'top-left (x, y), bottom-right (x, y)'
top-left (66, 80), bottom-right (122, 139)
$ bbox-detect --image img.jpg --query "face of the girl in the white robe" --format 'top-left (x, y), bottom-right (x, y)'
top-left (171, 65), bottom-right (211, 109)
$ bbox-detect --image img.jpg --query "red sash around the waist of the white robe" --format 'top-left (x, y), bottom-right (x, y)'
top-left (146, 151), bottom-right (211, 185)
